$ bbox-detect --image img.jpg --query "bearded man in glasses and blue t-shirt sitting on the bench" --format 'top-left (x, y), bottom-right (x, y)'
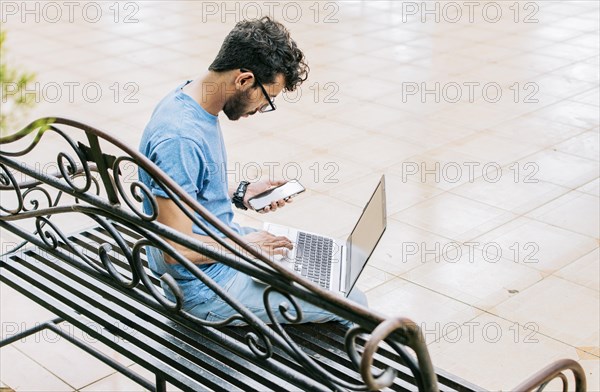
top-left (140, 17), bottom-right (366, 325)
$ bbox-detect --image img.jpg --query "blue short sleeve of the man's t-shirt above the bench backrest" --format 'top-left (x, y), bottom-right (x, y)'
top-left (149, 138), bottom-right (206, 197)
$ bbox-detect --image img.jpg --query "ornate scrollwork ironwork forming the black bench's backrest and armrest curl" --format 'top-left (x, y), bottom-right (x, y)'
top-left (0, 118), bottom-right (446, 391)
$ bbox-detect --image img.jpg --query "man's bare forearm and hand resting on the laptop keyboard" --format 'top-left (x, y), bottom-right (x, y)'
top-left (156, 197), bottom-right (292, 264)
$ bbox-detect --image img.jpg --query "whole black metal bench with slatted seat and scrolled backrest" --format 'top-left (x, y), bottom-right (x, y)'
top-left (0, 118), bottom-right (585, 392)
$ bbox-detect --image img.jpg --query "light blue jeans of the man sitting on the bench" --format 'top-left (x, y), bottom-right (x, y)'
top-left (186, 272), bottom-right (367, 326)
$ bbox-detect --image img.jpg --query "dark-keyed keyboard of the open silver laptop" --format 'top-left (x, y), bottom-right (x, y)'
top-left (294, 232), bottom-right (333, 289)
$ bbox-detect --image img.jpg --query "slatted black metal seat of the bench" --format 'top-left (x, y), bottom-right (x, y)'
top-left (0, 219), bottom-right (480, 392)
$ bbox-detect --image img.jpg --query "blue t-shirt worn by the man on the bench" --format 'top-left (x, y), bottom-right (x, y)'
top-left (139, 81), bottom-right (247, 306)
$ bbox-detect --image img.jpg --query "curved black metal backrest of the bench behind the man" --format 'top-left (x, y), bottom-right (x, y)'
top-left (0, 118), bottom-right (438, 391)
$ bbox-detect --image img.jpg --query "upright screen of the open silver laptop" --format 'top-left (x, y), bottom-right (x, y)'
top-left (346, 176), bottom-right (387, 295)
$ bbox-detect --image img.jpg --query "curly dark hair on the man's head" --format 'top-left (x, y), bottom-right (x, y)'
top-left (208, 16), bottom-right (309, 91)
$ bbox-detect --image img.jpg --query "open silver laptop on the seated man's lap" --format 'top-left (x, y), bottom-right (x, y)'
top-left (264, 176), bottom-right (387, 297)
